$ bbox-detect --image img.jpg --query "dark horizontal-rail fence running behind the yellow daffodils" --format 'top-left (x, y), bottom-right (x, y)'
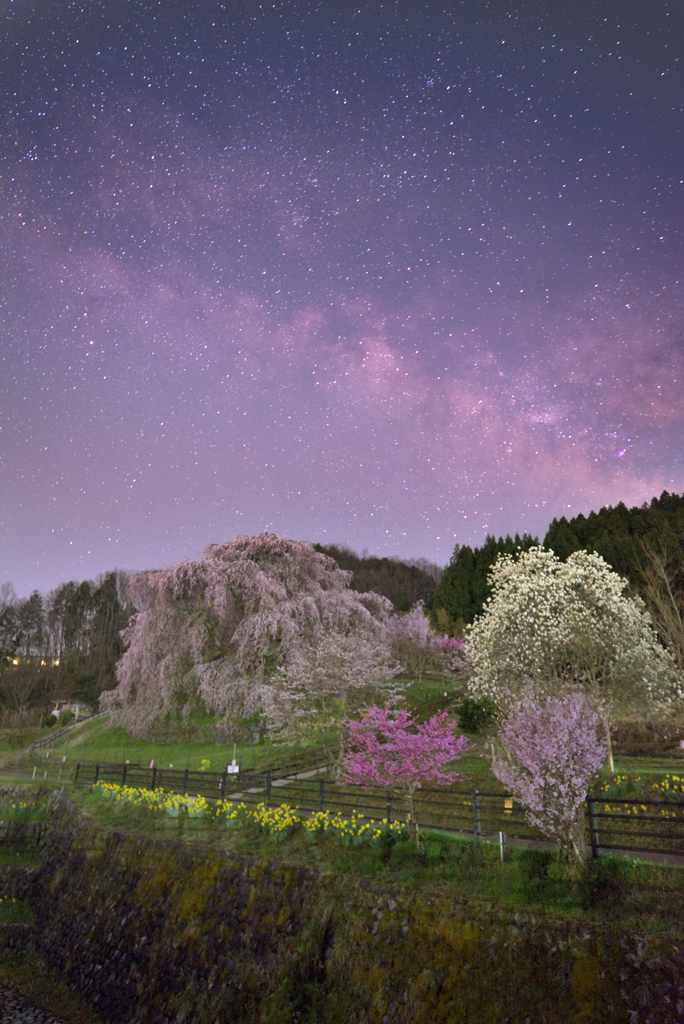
top-left (3, 758), bottom-right (684, 857)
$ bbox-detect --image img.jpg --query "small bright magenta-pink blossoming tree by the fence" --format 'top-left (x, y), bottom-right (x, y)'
top-left (340, 705), bottom-right (470, 842)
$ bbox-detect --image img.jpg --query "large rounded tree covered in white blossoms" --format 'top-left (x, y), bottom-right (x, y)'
top-left (467, 548), bottom-right (683, 771)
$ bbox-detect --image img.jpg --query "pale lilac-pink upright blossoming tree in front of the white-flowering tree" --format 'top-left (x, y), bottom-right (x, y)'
top-left (491, 684), bottom-right (606, 863)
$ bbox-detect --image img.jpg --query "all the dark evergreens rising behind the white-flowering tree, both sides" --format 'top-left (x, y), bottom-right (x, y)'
top-left (431, 490), bottom-right (684, 633)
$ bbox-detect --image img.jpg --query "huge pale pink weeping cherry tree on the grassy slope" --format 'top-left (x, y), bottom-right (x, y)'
top-left (101, 534), bottom-right (398, 743)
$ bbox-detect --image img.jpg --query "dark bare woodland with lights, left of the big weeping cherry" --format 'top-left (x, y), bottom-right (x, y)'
top-left (0, 571), bottom-right (134, 714)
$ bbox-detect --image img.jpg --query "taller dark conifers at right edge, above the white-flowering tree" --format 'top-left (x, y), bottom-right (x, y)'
top-left (544, 490), bottom-right (684, 591)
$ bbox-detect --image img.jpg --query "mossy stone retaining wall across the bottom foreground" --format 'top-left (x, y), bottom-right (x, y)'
top-left (6, 815), bottom-right (684, 1024)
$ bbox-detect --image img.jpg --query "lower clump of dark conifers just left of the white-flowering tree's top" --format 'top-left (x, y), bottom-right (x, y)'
top-left (432, 534), bottom-right (539, 630)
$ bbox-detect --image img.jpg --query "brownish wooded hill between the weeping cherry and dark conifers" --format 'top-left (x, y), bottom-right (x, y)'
top-left (314, 544), bottom-right (441, 611)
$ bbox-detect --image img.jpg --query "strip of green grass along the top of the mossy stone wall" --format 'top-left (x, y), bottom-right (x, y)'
top-left (72, 793), bottom-right (684, 935)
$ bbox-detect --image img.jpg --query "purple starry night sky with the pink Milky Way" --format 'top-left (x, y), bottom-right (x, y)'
top-left (0, 0), bottom-right (684, 594)
